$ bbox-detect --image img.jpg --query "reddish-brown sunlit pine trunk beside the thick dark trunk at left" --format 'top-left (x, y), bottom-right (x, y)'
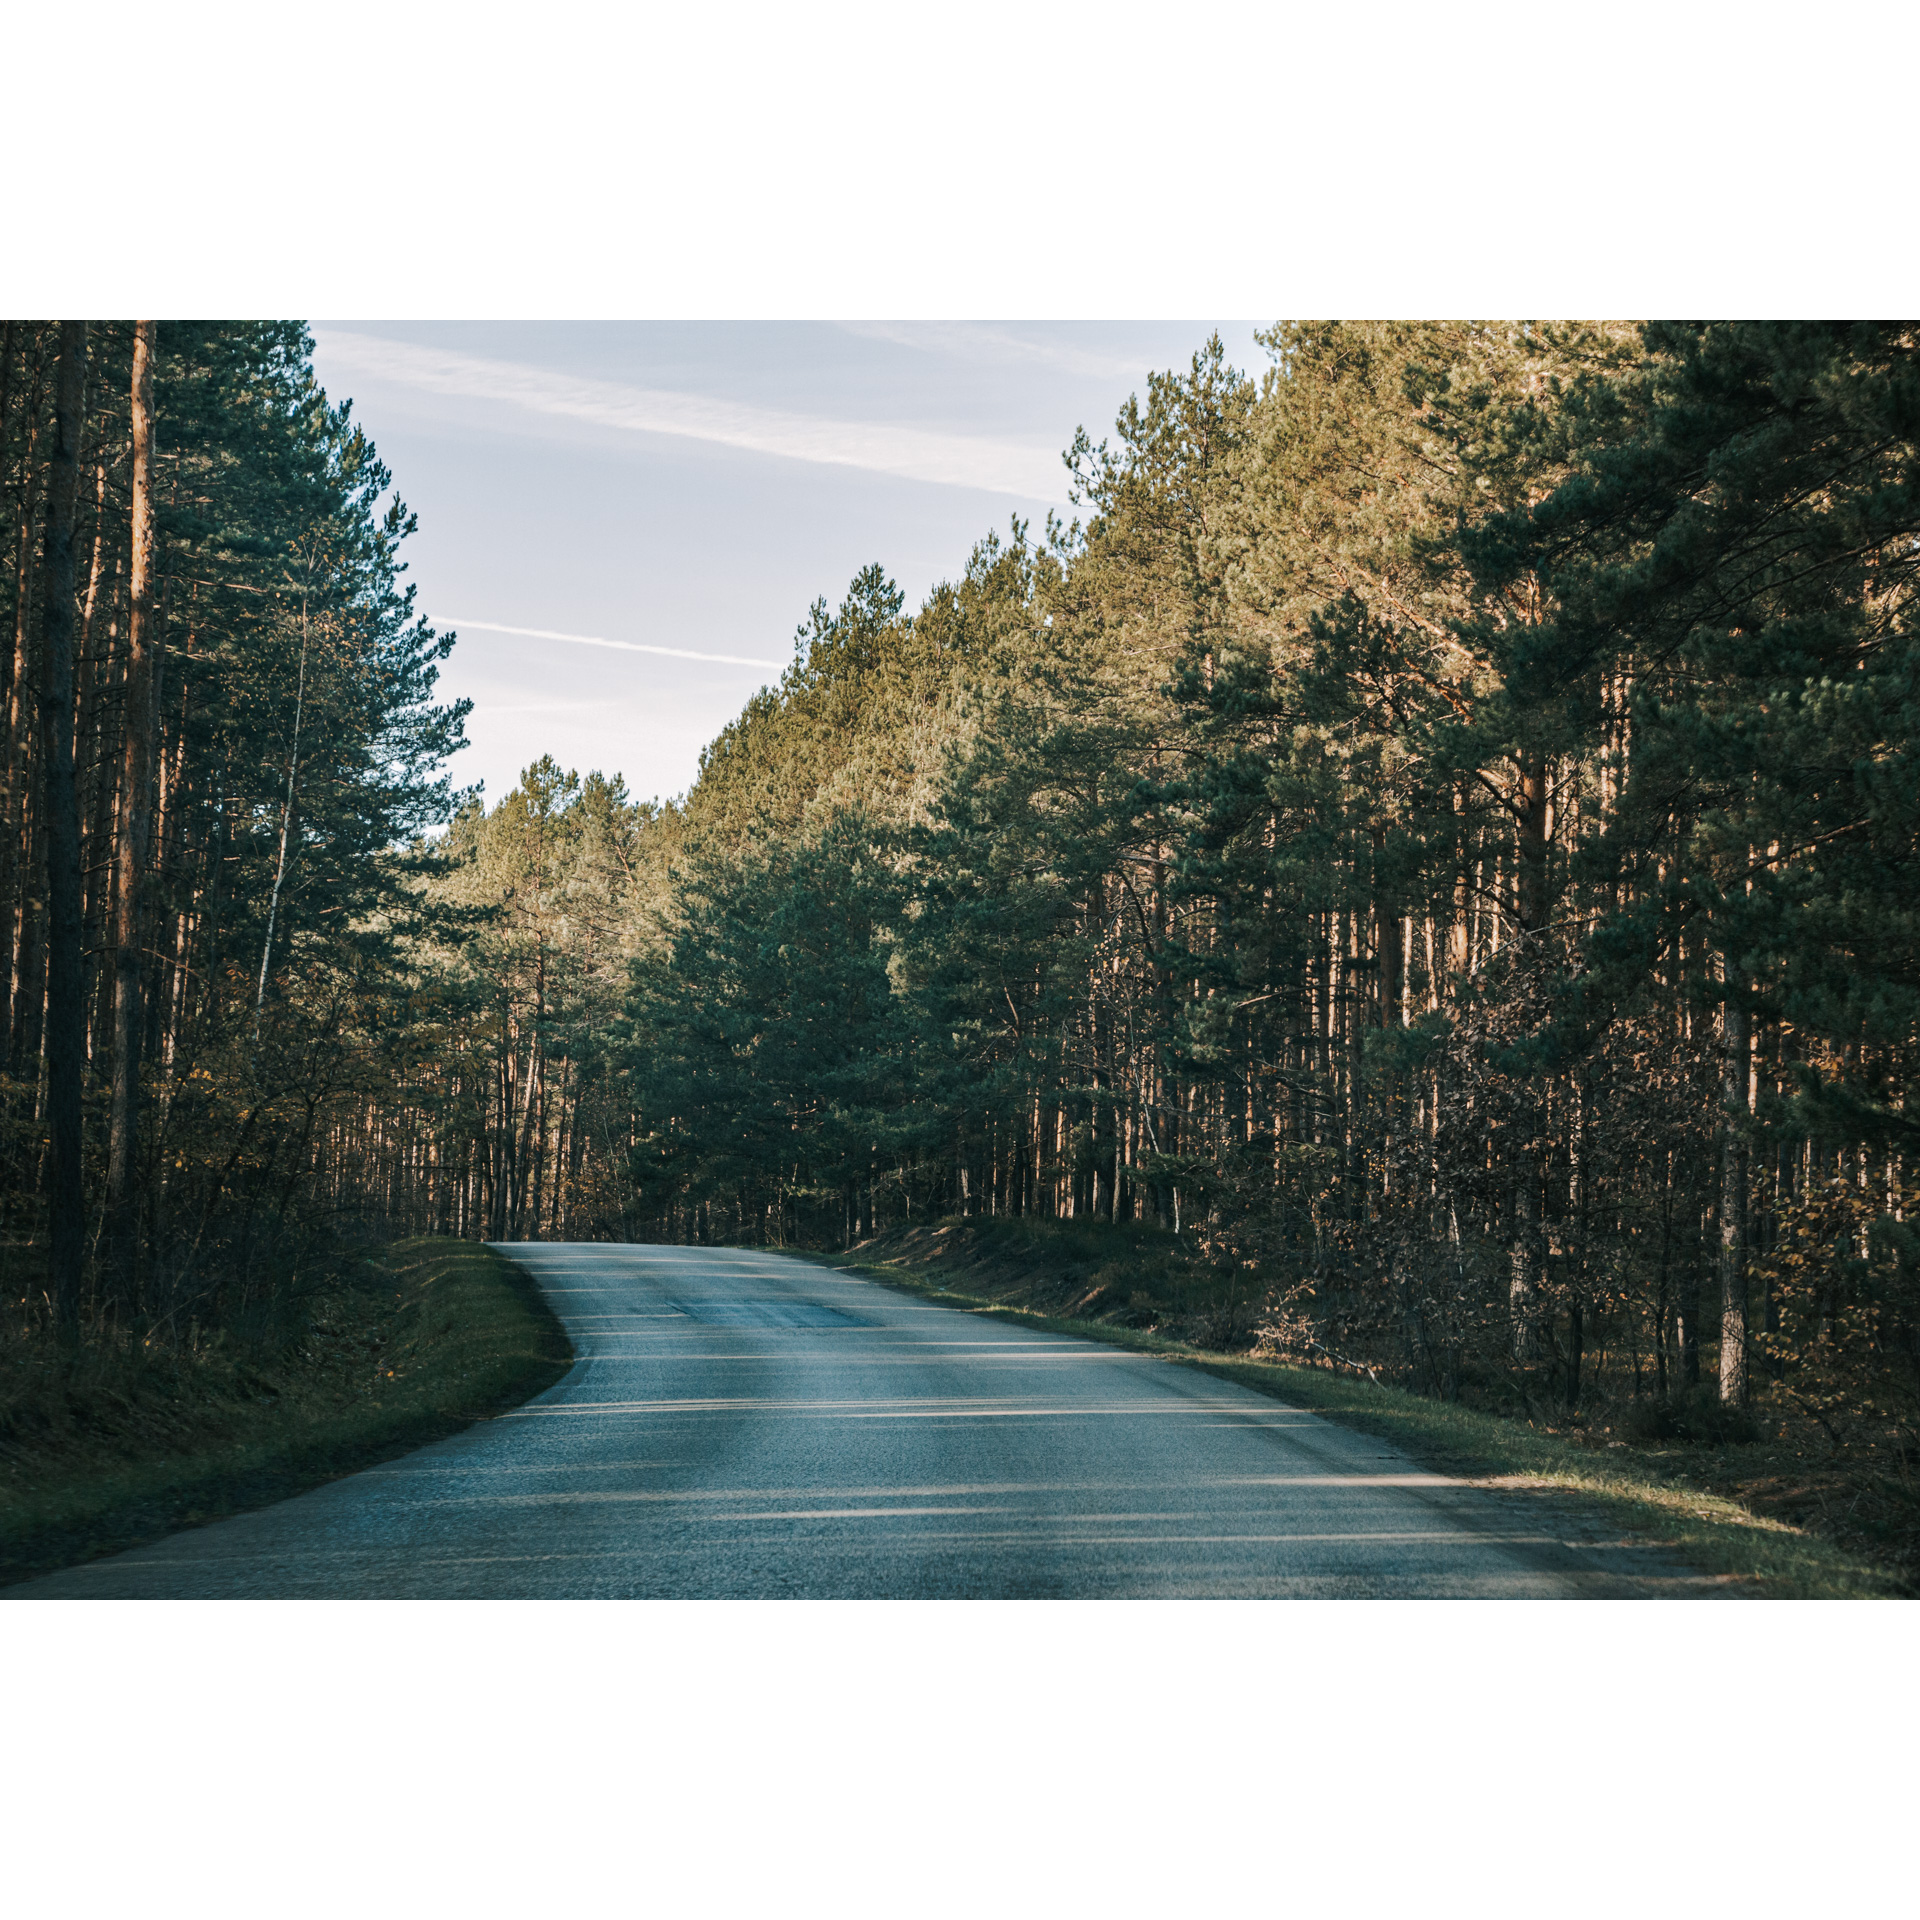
top-left (106, 321), bottom-right (159, 1311)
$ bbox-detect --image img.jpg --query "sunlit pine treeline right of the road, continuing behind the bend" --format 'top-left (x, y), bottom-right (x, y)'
top-left (366, 324), bottom-right (1920, 1448)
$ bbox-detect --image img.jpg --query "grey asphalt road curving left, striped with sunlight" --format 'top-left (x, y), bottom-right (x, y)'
top-left (8, 1246), bottom-right (1701, 1599)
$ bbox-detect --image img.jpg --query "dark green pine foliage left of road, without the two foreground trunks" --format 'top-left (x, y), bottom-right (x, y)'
top-left (0, 323), bottom-right (467, 1342)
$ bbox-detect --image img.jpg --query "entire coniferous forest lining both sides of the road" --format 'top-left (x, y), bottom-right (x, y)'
top-left (0, 323), bottom-right (1920, 1574)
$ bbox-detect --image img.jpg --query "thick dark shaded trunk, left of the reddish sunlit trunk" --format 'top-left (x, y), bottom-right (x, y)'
top-left (40, 321), bottom-right (86, 1346)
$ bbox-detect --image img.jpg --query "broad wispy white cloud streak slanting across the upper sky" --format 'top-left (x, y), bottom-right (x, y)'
top-left (315, 326), bottom-right (1066, 506)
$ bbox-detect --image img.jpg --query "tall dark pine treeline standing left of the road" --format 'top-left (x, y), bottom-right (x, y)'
top-left (0, 321), bottom-right (463, 1348)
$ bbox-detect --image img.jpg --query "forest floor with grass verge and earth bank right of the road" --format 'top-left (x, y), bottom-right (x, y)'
top-left (820, 1219), bottom-right (1920, 1599)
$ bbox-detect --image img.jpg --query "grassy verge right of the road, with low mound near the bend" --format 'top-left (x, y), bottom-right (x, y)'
top-left (816, 1240), bottom-right (1910, 1599)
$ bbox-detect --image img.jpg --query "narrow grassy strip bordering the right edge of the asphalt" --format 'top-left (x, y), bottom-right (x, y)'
top-left (814, 1254), bottom-right (1912, 1599)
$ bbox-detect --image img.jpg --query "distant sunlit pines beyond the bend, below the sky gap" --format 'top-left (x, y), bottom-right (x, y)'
top-left (321, 758), bottom-right (664, 1240)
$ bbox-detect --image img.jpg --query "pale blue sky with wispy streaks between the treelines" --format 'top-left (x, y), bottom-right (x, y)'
top-left (311, 321), bottom-right (1267, 804)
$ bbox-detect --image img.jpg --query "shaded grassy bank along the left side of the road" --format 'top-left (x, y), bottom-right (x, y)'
top-left (0, 1238), bottom-right (572, 1586)
